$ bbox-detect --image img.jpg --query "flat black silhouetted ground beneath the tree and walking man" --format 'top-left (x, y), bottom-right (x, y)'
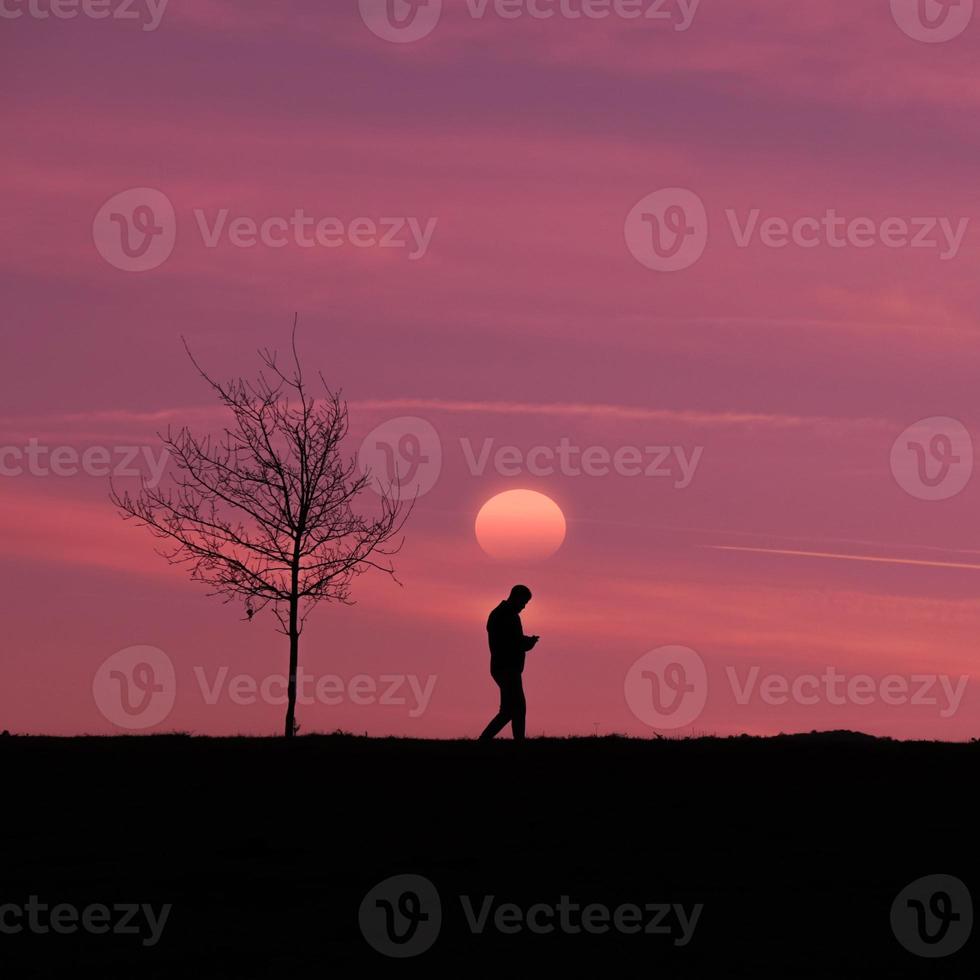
top-left (0, 733), bottom-right (980, 980)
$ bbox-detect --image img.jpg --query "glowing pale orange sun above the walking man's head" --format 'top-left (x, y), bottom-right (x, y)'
top-left (476, 490), bottom-right (565, 560)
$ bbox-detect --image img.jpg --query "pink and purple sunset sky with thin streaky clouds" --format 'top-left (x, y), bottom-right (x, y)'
top-left (0, 0), bottom-right (980, 740)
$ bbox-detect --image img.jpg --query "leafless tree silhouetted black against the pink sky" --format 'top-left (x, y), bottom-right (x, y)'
top-left (111, 320), bottom-right (411, 737)
